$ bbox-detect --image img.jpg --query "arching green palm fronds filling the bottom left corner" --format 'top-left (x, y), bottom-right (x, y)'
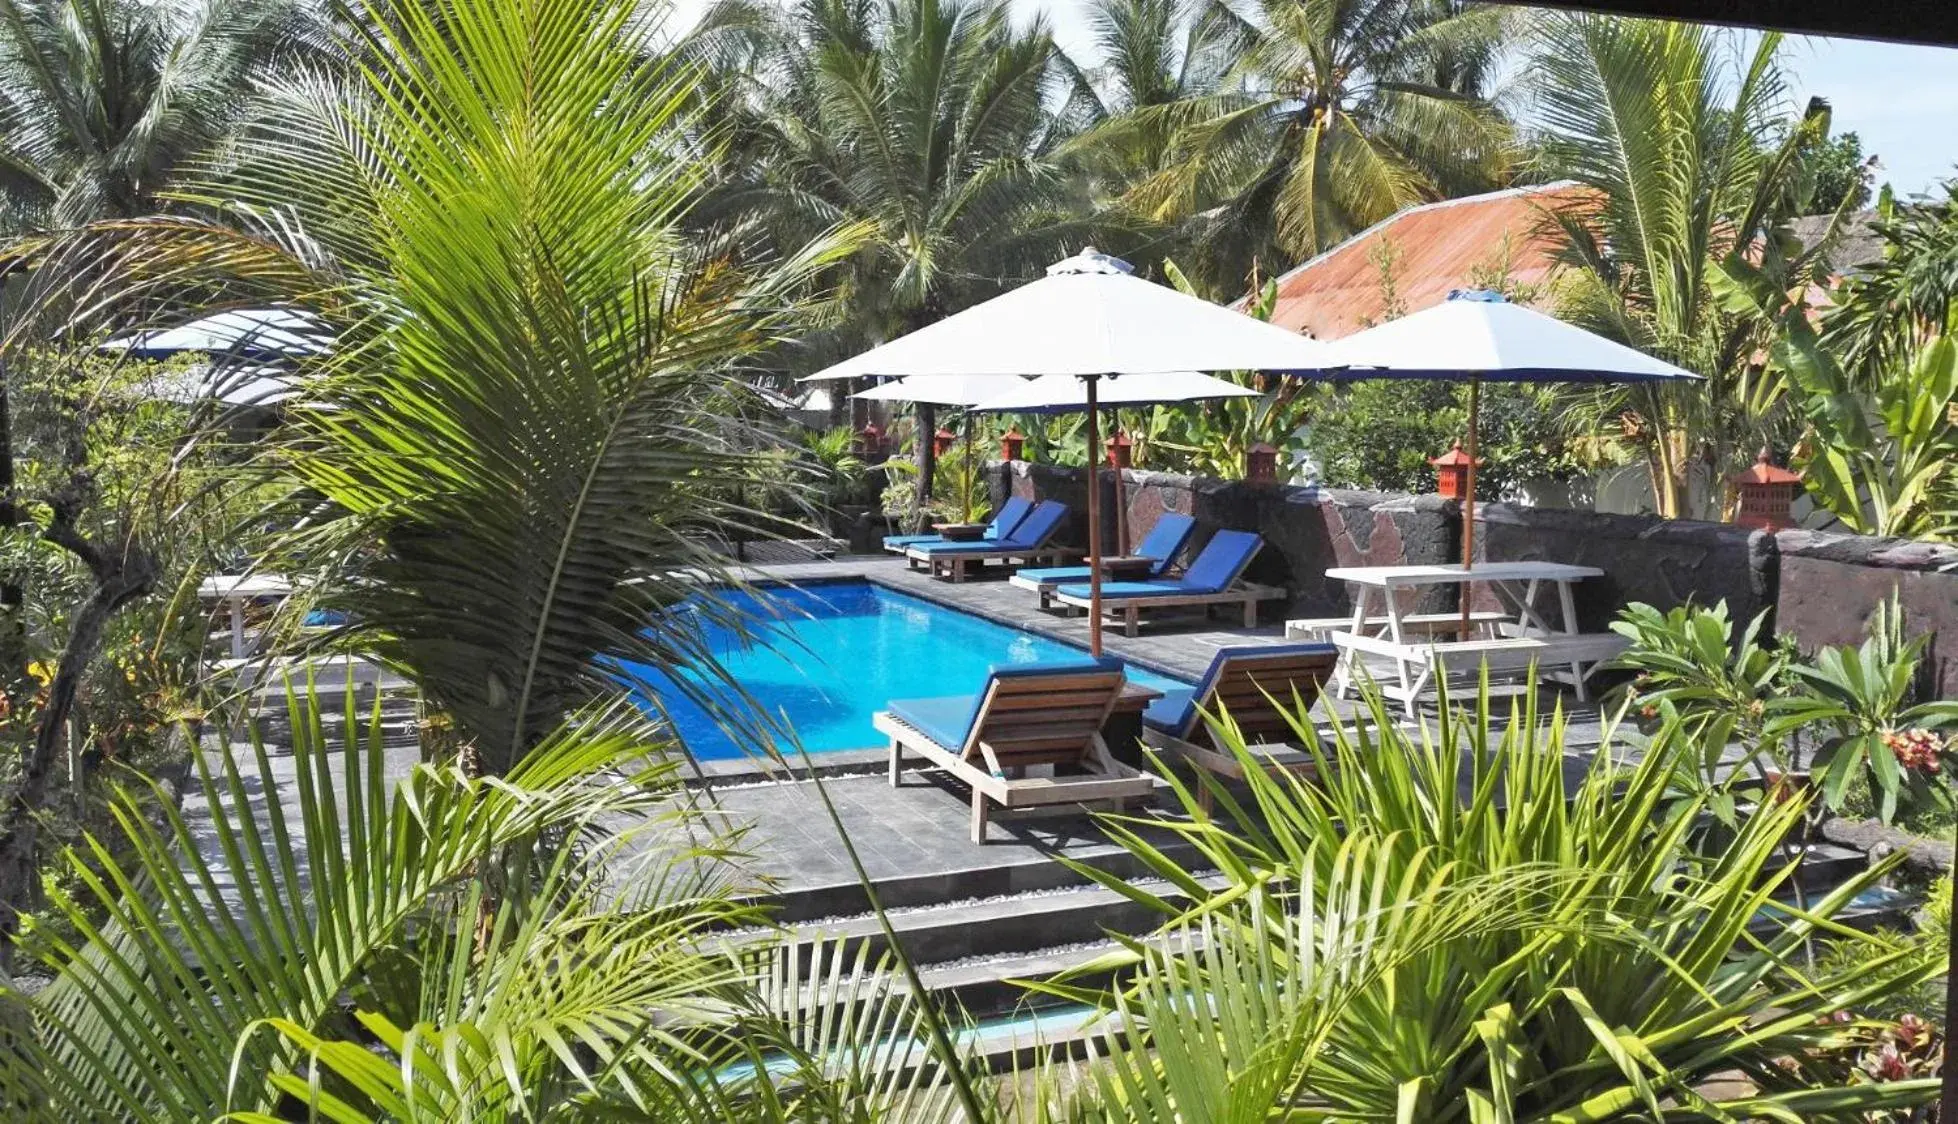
top-left (0, 693), bottom-right (802, 1120)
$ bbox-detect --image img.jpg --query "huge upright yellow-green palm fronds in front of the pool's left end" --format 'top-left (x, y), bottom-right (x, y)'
top-left (116, 0), bottom-right (846, 772)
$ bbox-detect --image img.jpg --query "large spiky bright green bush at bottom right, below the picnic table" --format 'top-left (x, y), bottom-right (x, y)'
top-left (1051, 695), bottom-right (1942, 1122)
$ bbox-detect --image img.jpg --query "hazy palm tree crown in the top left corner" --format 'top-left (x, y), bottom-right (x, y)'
top-left (0, 0), bottom-right (319, 233)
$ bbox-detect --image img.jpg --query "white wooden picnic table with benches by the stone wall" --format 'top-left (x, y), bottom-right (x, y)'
top-left (1298, 562), bottom-right (1625, 717)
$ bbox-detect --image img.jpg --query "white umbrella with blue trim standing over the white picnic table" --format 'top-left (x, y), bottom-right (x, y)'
top-left (1328, 290), bottom-right (1700, 632)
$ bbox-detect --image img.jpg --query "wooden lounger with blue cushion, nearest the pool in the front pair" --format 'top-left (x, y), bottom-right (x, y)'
top-left (871, 658), bottom-right (1155, 844)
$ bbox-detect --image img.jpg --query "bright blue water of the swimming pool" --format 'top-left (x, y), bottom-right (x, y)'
top-left (629, 582), bottom-right (1185, 760)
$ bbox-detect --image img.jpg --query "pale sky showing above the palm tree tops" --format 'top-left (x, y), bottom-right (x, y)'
top-left (677, 0), bottom-right (1958, 196)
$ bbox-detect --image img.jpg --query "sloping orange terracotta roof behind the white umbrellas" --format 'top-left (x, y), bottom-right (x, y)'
top-left (1239, 180), bottom-right (1588, 339)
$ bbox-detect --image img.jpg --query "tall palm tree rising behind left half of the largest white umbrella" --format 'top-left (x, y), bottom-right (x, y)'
top-left (687, 0), bottom-right (1098, 520)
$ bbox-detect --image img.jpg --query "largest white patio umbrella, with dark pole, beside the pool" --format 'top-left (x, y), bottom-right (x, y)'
top-left (809, 249), bottom-right (1329, 656)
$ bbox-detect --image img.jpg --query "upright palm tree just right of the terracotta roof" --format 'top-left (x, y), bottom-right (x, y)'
top-left (1533, 16), bottom-right (1827, 517)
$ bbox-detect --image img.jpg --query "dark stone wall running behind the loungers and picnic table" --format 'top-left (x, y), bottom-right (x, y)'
top-left (993, 462), bottom-right (1958, 697)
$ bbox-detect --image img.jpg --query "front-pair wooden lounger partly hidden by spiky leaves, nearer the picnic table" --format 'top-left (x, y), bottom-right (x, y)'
top-left (1142, 644), bottom-right (1339, 811)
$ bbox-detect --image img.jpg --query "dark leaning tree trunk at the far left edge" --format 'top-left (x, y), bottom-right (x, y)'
top-left (0, 528), bottom-right (157, 975)
